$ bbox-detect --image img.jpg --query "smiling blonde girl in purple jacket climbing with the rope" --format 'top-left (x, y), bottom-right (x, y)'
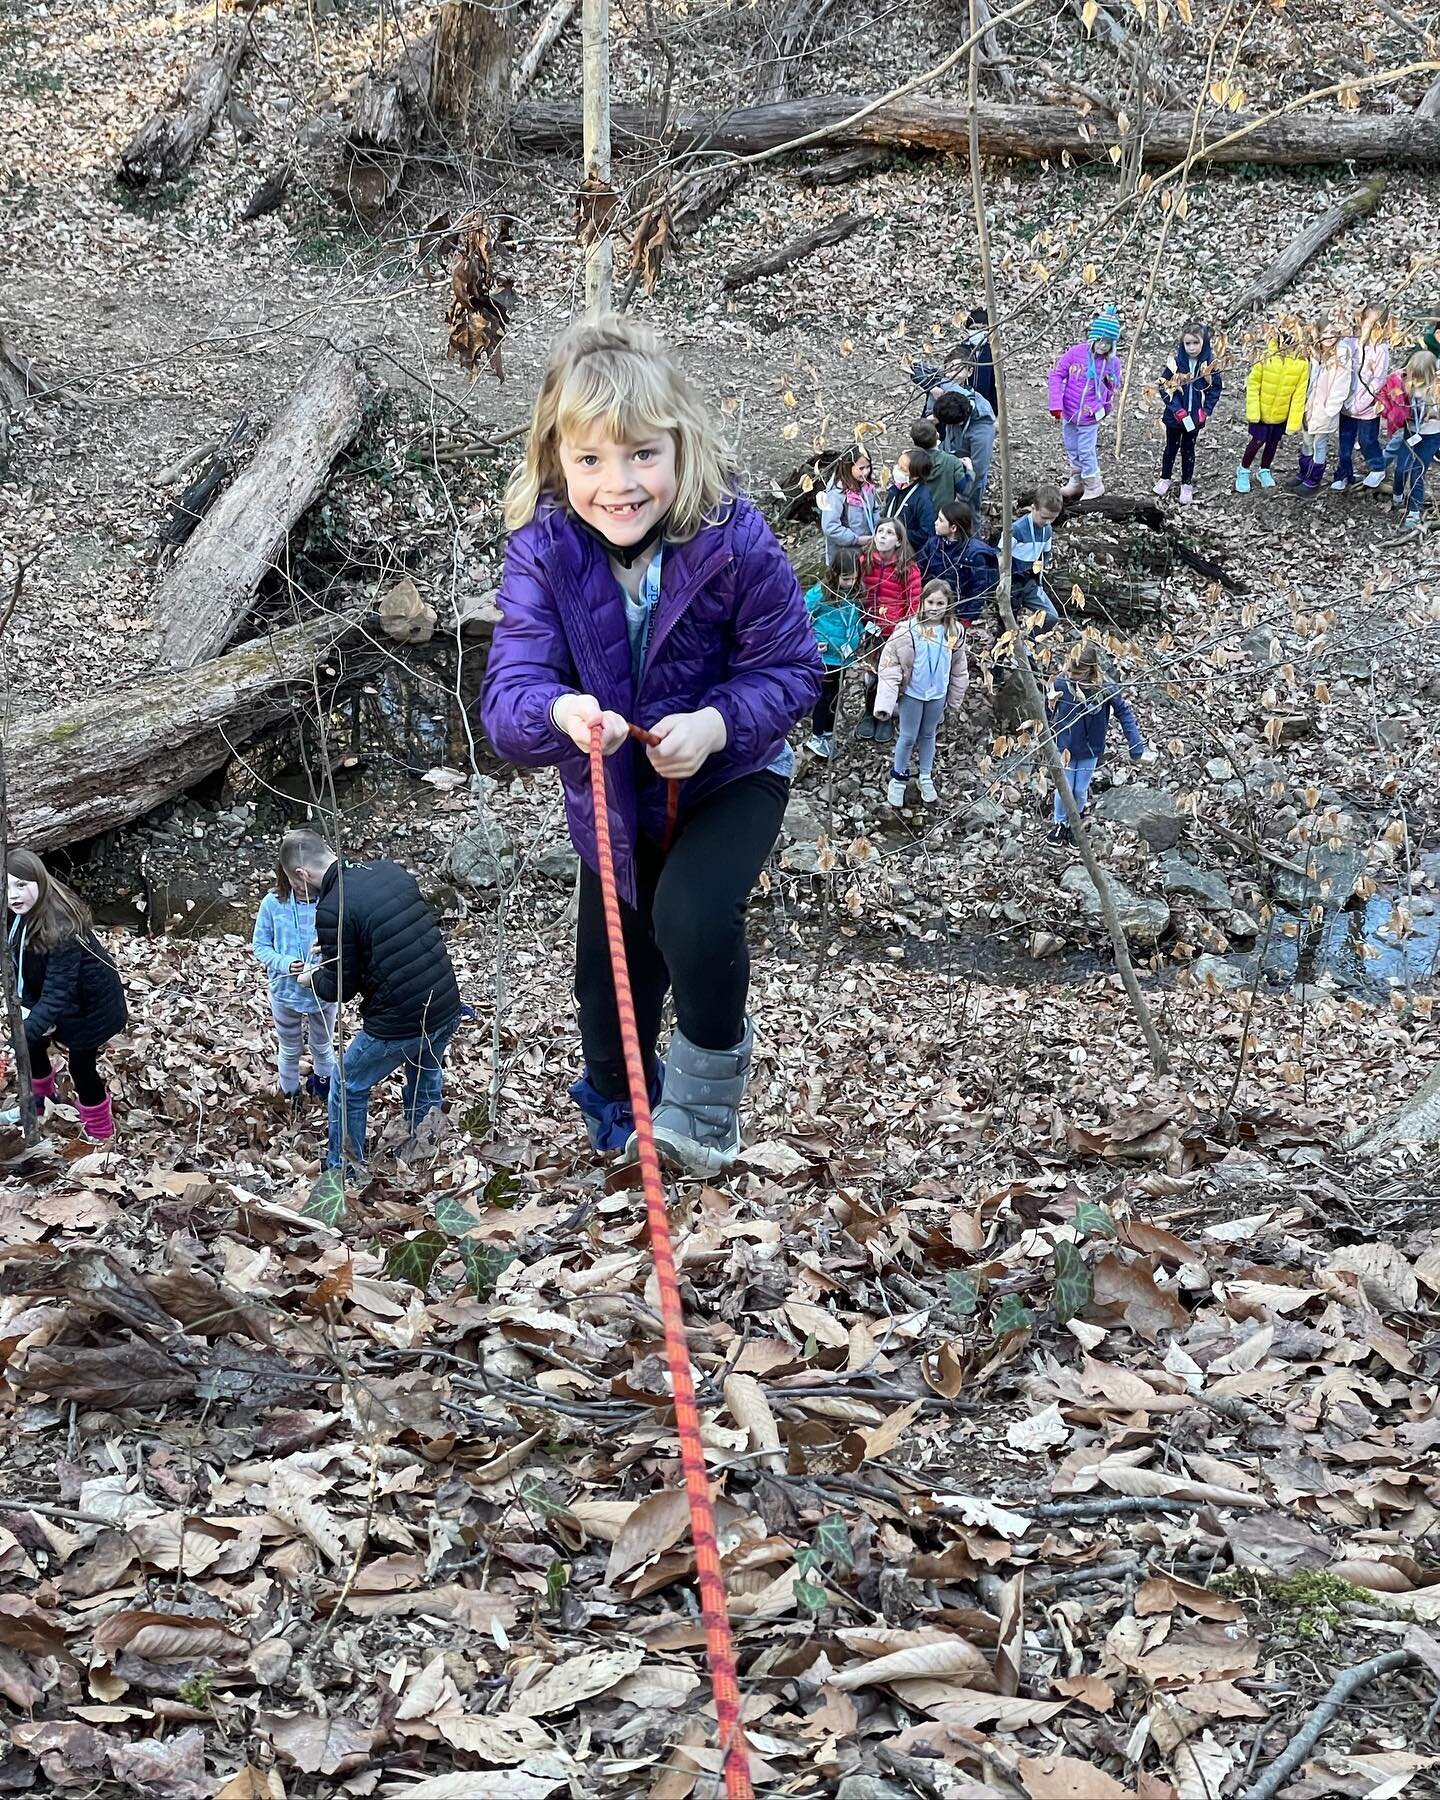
top-left (481, 317), bottom-right (821, 1174)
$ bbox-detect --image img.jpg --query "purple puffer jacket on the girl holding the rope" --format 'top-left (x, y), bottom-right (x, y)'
top-left (481, 495), bottom-right (823, 902)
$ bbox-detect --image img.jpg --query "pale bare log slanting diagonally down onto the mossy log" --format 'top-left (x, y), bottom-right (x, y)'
top-left (151, 349), bottom-right (365, 670)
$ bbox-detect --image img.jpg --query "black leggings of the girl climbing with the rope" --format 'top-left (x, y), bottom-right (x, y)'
top-left (574, 770), bottom-right (790, 1100)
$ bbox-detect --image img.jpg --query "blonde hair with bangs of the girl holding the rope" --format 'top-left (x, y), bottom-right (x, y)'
top-left (506, 313), bottom-right (736, 542)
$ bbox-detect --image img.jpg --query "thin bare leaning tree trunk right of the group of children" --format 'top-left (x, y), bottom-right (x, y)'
top-left (968, 0), bottom-right (1170, 1075)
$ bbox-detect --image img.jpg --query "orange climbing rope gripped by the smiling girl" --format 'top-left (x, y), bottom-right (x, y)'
top-left (590, 720), bottom-right (754, 1800)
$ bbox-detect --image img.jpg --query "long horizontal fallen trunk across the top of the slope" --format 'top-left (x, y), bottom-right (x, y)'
top-left (511, 94), bottom-right (1440, 167)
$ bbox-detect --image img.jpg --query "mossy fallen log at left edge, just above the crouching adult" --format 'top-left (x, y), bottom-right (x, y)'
top-left (5, 617), bottom-right (360, 850)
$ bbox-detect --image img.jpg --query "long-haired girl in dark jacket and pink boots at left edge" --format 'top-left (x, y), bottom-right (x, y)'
top-left (5, 850), bottom-right (130, 1143)
